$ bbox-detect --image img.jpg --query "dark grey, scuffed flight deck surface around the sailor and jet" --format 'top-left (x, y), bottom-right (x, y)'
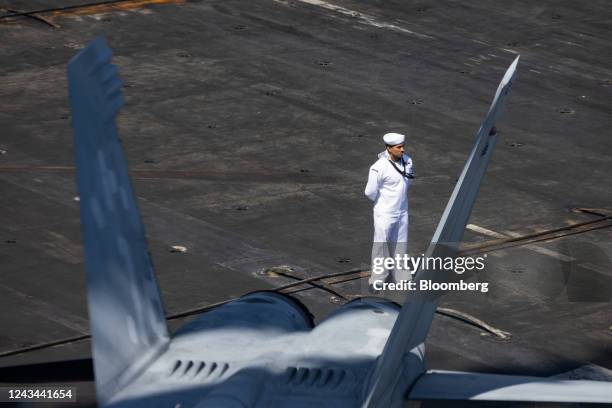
top-left (0, 0), bottom-right (612, 406)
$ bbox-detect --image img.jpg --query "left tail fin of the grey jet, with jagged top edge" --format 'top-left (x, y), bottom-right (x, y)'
top-left (68, 38), bottom-right (169, 405)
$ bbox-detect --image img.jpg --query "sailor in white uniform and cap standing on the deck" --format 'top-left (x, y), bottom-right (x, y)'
top-left (365, 133), bottom-right (414, 293)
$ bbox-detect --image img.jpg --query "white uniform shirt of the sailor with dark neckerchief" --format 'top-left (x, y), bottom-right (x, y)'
top-left (365, 150), bottom-right (412, 214)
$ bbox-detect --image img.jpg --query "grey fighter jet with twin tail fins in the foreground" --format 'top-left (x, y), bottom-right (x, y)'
top-left (68, 38), bottom-right (612, 408)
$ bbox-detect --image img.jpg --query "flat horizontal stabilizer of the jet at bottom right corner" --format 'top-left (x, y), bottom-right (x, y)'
top-left (409, 371), bottom-right (612, 403)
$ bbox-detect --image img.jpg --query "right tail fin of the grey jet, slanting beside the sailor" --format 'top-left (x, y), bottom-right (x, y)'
top-left (363, 57), bottom-right (519, 407)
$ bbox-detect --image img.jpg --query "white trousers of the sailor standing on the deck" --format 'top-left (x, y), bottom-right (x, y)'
top-left (368, 211), bottom-right (412, 284)
